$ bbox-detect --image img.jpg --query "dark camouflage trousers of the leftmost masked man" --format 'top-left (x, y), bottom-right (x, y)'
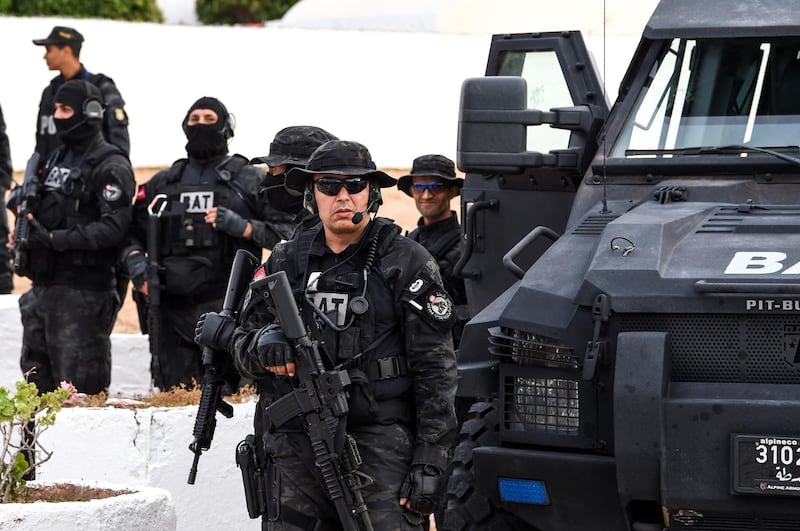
top-left (19, 285), bottom-right (119, 394)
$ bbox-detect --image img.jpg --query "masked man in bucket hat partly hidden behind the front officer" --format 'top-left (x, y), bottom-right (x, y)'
top-left (250, 125), bottom-right (337, 249)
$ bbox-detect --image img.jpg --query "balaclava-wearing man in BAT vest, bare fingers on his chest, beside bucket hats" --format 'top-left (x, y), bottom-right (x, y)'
top-left (123, 96), bottom-right (265, 390)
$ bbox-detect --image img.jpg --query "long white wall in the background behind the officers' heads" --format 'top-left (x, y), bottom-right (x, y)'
top-left (0, 11), bottom-right (644, 170)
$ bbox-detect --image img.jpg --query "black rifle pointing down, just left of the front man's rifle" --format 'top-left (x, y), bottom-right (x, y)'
top-left (188, 249), bottom-right (258, 485)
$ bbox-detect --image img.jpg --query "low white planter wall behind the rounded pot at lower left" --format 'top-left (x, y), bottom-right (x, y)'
top-left (37, 403), bottom-right (261, 531)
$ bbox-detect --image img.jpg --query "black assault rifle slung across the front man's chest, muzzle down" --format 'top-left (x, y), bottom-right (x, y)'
top-left (250, 271), bottom-right (373, 531)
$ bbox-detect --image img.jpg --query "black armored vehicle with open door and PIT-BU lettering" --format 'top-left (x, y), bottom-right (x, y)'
top-left (440, 0), bottom-right (800, 531)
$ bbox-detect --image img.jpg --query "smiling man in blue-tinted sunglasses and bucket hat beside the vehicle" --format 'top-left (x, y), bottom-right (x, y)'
top-left (397, 155), bottom-right (469, 348)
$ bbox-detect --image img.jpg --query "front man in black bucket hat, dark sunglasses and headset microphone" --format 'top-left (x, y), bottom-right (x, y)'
top-left (196, 140), bottom-right (456, 531)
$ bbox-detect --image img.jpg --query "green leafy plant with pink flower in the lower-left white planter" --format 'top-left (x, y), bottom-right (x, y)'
top-left (0, 381), bottom-right (70, 503)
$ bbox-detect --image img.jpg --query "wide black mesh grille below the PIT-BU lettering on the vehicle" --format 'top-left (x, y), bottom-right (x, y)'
top-left (619, 314), bottom-right (800, 384)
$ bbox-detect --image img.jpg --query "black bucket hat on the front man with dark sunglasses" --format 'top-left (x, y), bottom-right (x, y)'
top-left (286, 140), bottom-right (397, 192)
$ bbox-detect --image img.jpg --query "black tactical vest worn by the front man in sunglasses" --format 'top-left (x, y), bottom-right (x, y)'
top-left (277, 218), bottom-right (414, 427)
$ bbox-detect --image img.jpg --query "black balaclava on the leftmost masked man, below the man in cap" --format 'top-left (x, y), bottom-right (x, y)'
top-left (53, 79), bottom-right (103, 148)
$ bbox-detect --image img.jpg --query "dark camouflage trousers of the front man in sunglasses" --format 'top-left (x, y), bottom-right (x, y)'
top-left (262, 424), bottom-right (427, 531)
